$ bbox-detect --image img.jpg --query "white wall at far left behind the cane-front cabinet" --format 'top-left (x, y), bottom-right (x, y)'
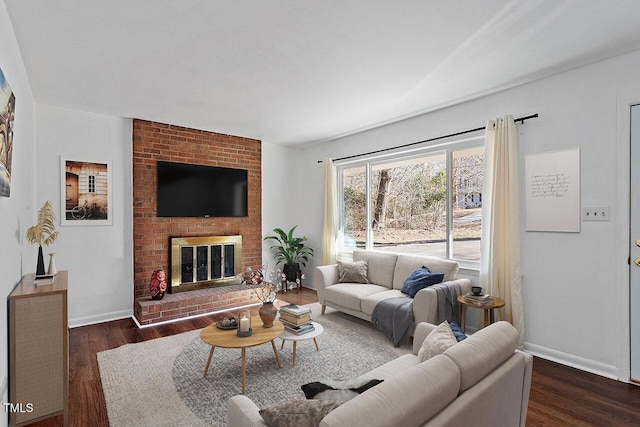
top-left (0, 2), bottom-right (36, 425)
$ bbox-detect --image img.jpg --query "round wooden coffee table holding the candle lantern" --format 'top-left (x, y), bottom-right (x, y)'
top-left (200, 320), bottom-right (284, 394)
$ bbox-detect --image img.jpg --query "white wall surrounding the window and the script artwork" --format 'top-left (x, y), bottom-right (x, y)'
top-left (282, 53), bottom-right (640, 380)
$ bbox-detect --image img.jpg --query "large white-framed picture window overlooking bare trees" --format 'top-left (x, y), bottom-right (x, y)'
top-left (338, 138), bottom-right (484, 266)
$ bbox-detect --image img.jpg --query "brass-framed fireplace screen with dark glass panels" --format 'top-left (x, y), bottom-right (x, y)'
top-left (170, 236), bottom-right (242, 292)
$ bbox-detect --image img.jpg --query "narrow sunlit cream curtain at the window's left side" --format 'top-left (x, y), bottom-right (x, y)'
top-left (322, 158), bottom-right (338, 265)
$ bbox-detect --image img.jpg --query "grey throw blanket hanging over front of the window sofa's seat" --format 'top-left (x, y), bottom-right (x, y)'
top-left (371, 296), bottom-right (414, 347)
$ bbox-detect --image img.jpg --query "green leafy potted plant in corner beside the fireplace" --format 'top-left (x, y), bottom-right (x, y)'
top-left (264, 225), bottom-right (313, 282)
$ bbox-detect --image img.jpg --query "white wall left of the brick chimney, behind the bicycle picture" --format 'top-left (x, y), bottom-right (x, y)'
top-left (36, 105), bottom-right (133, 326)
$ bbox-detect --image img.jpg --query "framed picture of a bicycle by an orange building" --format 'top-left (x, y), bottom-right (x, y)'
top-left (60, 157), bottom-right (113, 226)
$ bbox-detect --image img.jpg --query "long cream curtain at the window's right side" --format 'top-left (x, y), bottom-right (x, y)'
top-left (480, 116), bottom-right (524, 348)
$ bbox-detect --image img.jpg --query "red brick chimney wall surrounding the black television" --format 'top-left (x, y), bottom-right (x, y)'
top-left (133, 119), bottom-right (262, 298)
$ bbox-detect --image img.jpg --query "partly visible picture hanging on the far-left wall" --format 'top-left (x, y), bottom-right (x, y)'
top-left (0, 69), bottom-right (16, 197)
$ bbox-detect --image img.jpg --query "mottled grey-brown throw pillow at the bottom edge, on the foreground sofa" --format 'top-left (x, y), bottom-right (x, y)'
top-left (259, 400), bottom-right (342, 427)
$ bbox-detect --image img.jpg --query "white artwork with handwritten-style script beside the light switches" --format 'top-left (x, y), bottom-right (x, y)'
top-left (524, 148), bottom-right (580, 233)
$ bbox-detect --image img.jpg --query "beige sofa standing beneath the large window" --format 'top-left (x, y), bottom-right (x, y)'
top-left (313, 250), bottom-right (471, 324)
